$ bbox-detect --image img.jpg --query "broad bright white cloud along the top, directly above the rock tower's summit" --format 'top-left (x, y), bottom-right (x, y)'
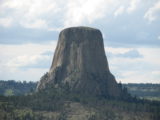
top-left (0, 0), bottom-right (129, 30)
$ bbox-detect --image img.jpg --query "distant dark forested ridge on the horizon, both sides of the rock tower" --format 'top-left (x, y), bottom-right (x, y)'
top-left (0, 80), bottom-right (160, 100)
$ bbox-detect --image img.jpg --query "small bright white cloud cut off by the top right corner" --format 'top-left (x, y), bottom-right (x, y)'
top-left (144, 1), bottom-right (160, 22)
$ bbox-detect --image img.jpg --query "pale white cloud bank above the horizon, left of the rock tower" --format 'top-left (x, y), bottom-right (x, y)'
top-left (0, 41), bottom-right (57, 81)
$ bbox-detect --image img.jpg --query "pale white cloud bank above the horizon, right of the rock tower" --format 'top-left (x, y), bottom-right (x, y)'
top-left (105, 47), bottom-right (160, 83)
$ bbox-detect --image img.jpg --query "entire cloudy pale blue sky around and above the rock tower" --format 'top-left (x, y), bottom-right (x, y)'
top-left (0, 0), bottom-right (160, 83)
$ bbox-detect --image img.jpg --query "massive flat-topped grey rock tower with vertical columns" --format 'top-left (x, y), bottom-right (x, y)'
top-left (37, 27), bottom-right (121, 96)
